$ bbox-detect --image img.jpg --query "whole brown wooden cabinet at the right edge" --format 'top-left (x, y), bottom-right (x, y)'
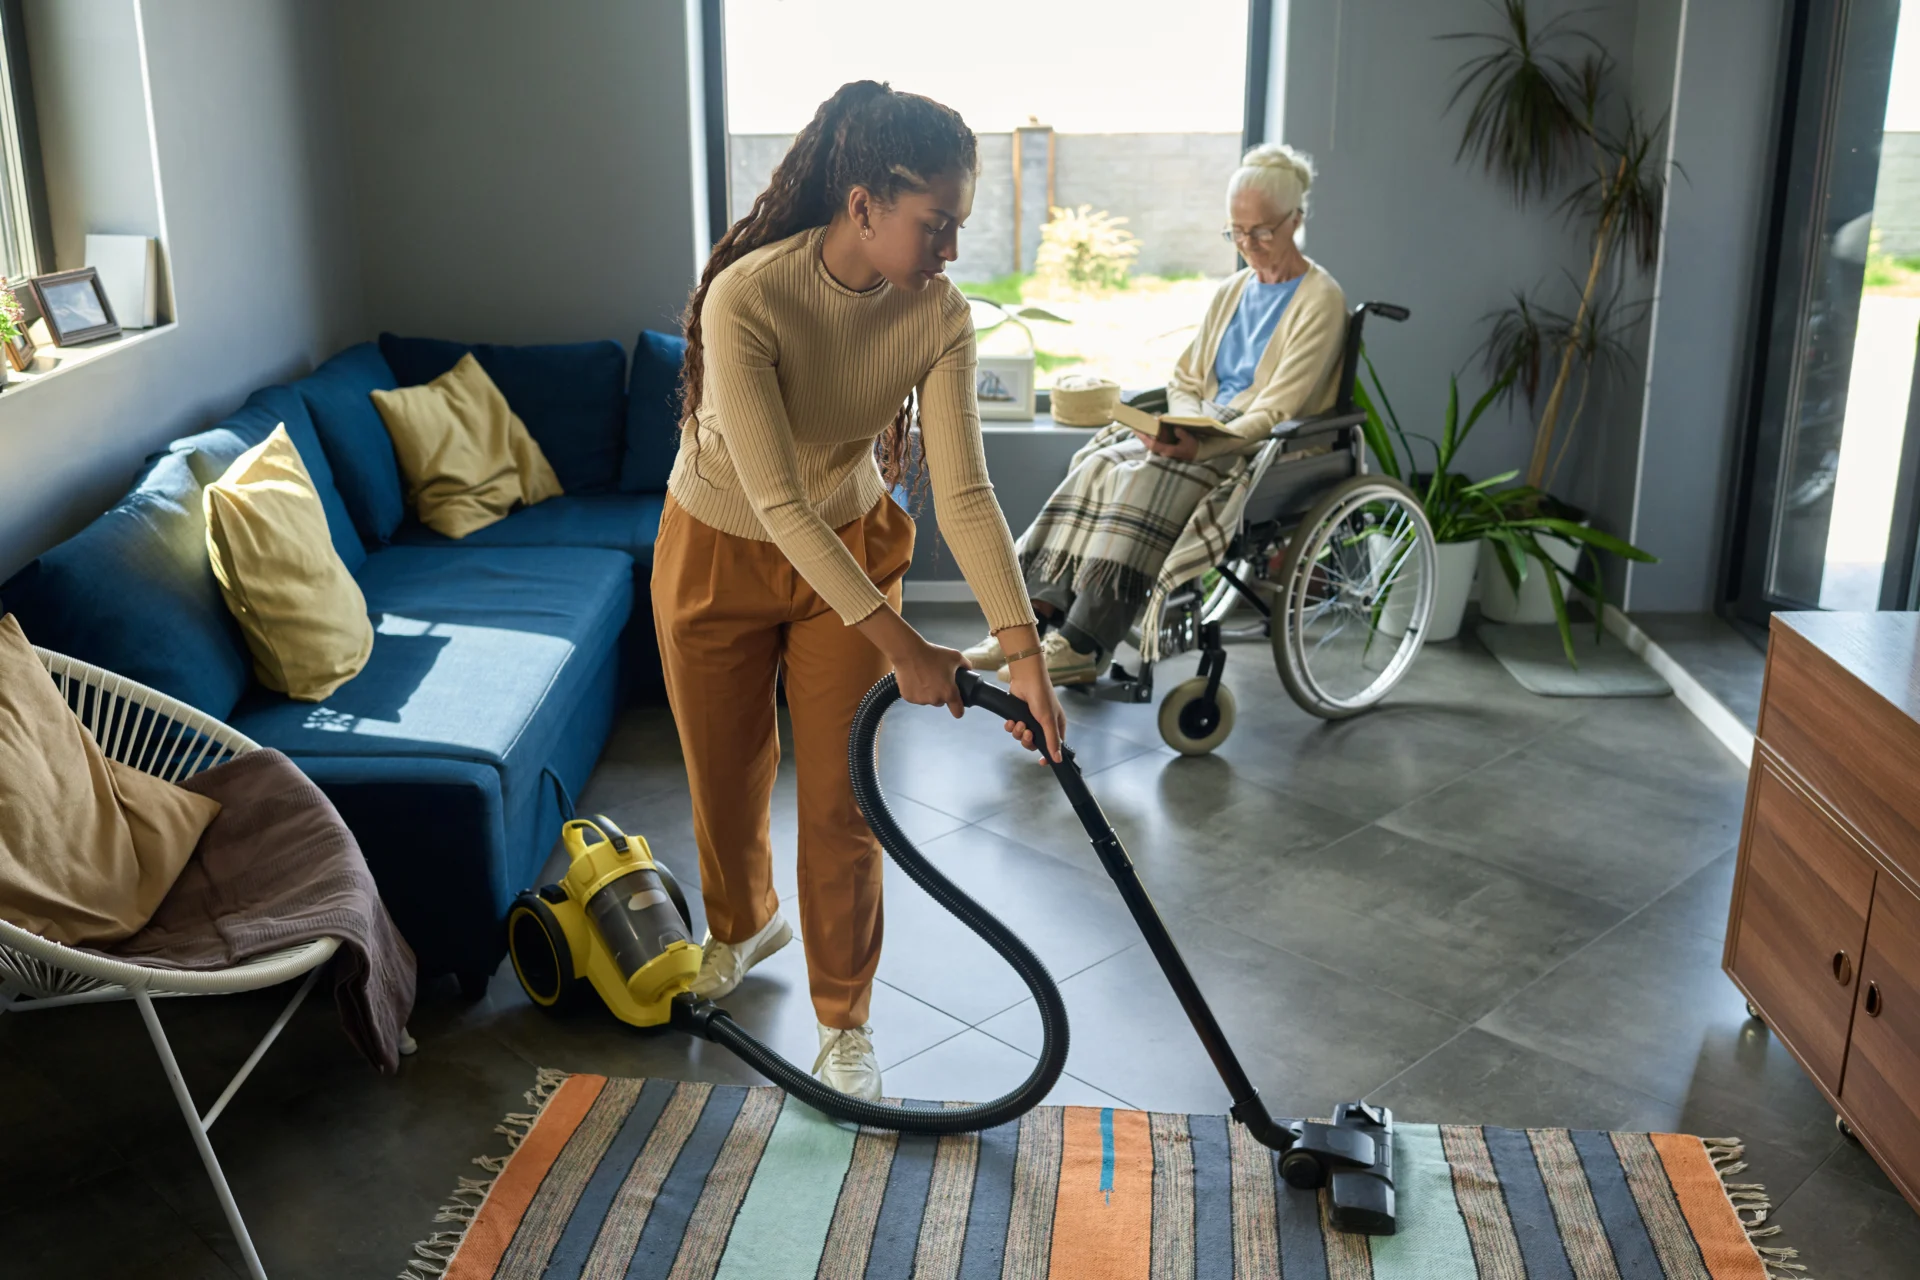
top-left (1724, 614), bottom-right (1920, 1209)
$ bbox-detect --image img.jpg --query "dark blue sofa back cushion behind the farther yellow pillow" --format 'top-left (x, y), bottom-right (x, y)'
top-left (380, 334), bottom-right (626, 493)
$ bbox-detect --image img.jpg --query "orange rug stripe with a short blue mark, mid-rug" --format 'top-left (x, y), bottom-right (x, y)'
top-left (1048, 1107), bottom-right (1154, 1280)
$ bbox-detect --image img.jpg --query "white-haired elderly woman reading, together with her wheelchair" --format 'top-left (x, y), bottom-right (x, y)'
top-left (966, 146), bottom-right (1434, 754)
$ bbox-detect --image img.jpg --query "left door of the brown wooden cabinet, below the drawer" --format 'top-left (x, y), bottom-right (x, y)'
top-left (1726, 750), bottom-right (1876, 1094)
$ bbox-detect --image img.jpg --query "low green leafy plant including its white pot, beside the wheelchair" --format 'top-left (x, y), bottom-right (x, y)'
top-left (1354, 353), bottom-right (1653, 670)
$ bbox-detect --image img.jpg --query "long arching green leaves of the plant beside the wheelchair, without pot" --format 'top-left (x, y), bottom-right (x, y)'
top-left (1354, 353), bottom-right (1653, 668)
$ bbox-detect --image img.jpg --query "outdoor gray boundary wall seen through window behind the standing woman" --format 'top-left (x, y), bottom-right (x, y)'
top-left (728, 130), bottom-right (1240, 280)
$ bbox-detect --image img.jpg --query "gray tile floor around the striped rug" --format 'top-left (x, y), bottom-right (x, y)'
top-left (0, 608), bottom-right (1920, 1280)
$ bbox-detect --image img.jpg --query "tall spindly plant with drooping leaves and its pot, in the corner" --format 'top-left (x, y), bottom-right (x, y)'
top-left (1440, 0), bottom-right (1684, 622)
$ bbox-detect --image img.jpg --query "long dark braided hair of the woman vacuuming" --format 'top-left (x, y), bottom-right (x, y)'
top-left (680, 81), bottom-right (979, 487)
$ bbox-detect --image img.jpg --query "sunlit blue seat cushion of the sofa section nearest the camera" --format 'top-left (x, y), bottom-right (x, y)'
top-left (230, 547), bottom-right (634, 817)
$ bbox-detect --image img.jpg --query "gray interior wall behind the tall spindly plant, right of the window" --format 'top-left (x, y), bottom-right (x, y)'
top-left (1281, 0), bottom-right (1657, 525)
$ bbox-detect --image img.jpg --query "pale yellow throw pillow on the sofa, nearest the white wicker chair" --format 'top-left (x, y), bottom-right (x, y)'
top-left (204, 426), bottom-right (372, 702)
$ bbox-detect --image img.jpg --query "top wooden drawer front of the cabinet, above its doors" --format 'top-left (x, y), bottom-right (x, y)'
top-left (1759, 618), bottom-right (1920, 852)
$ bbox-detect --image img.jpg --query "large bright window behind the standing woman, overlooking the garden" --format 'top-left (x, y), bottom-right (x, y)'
top-left (726, 0), bottom-right (1250, 388)
